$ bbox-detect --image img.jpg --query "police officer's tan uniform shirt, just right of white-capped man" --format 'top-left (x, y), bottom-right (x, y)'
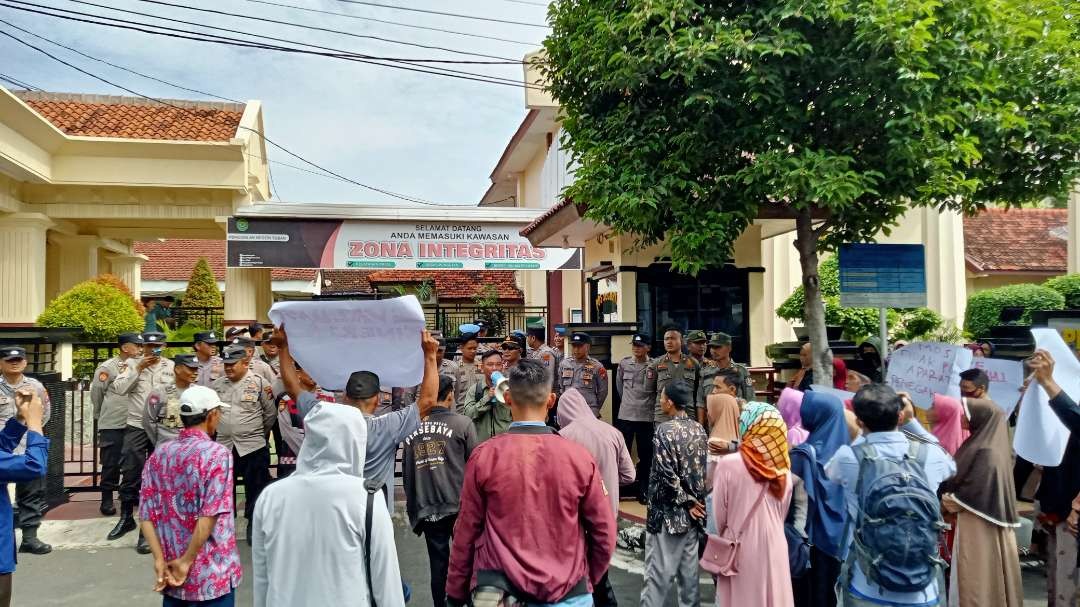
top-left (211, 369), bottom-right (278, 457)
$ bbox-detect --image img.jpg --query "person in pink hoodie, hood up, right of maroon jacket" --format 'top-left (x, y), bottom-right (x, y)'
top-left (558, 388), bottom-right (636, 605)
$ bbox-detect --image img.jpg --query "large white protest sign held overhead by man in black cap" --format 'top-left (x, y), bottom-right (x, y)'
top-left (270, 295), bottom-right (424, 390)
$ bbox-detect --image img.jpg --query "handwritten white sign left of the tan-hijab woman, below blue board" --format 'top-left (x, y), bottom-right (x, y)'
top-left (886, 341), bottom-right (971, 409)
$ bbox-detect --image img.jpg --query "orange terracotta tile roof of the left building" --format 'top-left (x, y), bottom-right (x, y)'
top-left (17, 92), bottom-right (243, 141)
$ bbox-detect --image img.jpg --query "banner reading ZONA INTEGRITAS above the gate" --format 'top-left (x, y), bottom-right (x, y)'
top-left (227, 217), bottom-right (581, 270)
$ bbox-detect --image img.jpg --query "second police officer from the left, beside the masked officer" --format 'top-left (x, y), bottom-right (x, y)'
top-left (90, 333), bottom-right (143, 516)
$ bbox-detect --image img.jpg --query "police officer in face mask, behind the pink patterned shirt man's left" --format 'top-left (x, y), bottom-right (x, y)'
top-left (107, 333), bottom-right (175, 553)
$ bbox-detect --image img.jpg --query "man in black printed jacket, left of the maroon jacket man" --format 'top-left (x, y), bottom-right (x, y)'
top-left (402, 375), bottom-right (477, 607)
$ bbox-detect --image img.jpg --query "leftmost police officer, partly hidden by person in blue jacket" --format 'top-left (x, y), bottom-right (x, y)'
top-left (0, 346), bottom-right (53, 554)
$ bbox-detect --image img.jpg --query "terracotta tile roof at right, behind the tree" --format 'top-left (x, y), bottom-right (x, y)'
top-left (963, 208), bottom-right (1068, 274)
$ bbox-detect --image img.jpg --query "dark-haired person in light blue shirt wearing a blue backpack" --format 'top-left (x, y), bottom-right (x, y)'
top-left (825, 383), bottom-right (956, 607)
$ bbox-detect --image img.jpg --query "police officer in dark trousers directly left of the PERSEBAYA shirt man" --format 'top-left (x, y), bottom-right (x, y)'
top-left (615, 334), bottom-right (653, 503)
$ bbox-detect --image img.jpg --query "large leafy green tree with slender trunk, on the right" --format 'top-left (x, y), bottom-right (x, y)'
top-left (541, 0), bottom-right (1080, 382)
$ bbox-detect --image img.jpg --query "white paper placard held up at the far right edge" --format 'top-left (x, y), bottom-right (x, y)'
top-left (1013, 328), bottom-right (1080, 466)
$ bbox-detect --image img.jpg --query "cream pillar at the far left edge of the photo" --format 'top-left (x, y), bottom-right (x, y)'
top-left (0, 213), bottom-right (53, 326)
